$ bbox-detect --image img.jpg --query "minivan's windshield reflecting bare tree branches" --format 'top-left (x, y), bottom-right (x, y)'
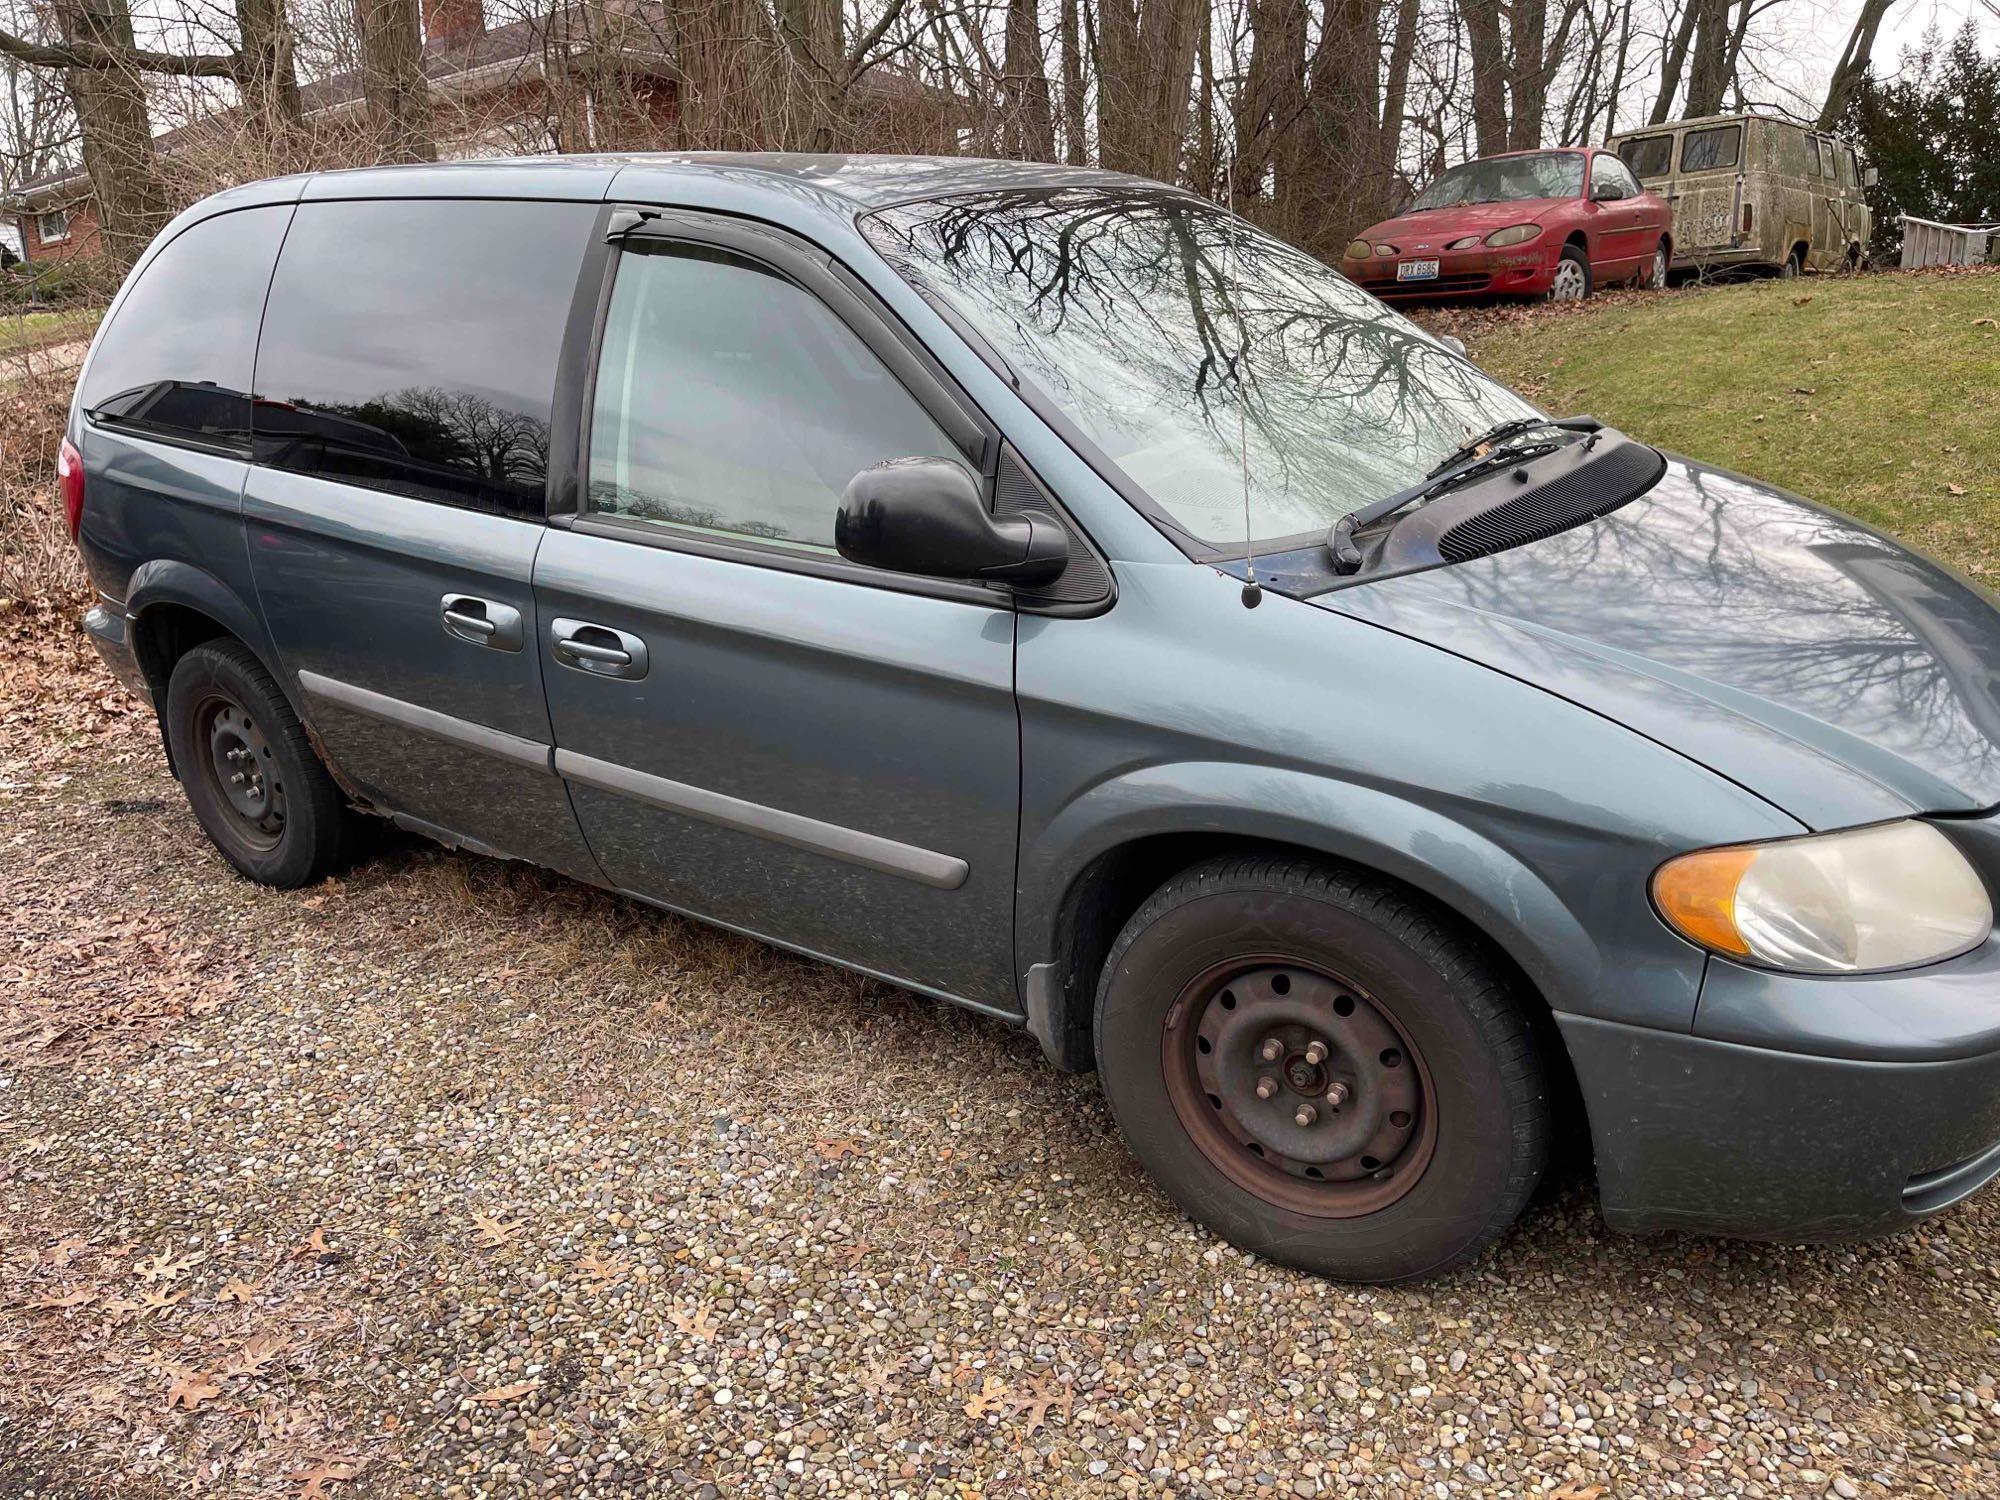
top-left (862, 187), bottom-right (1528, 552)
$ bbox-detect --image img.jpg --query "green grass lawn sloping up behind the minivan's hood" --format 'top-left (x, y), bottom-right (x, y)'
top-left (1460, 274), bottom-right (2000, 586)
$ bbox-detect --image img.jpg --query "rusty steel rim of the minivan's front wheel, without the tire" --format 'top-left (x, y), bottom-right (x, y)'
top-left (1160, 956), bottom-right (1438, 1218)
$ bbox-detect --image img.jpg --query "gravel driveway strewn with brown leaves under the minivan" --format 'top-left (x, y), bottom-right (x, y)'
top-left (0, 620), bottom-right (2000, 1500)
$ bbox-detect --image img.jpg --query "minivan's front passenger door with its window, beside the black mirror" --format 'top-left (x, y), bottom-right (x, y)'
top-left (534, 214), bottom-right (1020, 1012)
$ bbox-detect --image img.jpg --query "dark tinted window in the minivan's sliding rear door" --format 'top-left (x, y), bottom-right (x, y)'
top-left (254, 198), bottom-right (596, 516)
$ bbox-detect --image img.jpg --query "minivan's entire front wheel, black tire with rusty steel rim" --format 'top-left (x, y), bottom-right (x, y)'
top-left (1096, 858), bottom-right (1548, 1282)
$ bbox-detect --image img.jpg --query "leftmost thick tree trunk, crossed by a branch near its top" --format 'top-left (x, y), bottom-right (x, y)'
top-left (56, 0), bottom-right (168, 266)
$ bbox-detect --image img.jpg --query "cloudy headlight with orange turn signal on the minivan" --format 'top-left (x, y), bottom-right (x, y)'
top-left (1652, 822), bottom-right (1994, 974)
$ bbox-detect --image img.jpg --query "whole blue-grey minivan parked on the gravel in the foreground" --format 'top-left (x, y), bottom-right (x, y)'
top-left (60, 156), bottom-right (2000, 1280)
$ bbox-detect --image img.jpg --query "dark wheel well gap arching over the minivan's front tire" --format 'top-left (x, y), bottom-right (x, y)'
top-left (1044, 834), bottom-right (1590, 1170)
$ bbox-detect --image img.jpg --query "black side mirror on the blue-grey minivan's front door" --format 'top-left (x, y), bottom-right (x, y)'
top-left (834, 458), bottom-right (1070, 588)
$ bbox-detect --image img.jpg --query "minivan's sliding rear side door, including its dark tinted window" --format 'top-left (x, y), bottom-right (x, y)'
top-left (244, 198), bottom-right (598, 878)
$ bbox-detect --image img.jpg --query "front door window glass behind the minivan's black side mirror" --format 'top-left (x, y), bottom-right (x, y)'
top-left (588, 244), bottom-right (956, 552)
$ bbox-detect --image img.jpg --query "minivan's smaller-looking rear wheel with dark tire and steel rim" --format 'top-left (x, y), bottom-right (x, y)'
top-left (166, 640), bottom-right (354, 890)
